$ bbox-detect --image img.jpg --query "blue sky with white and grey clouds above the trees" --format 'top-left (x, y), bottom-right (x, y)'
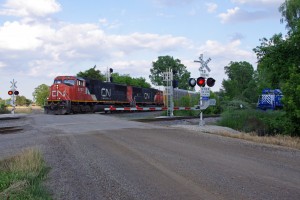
top-left (0, 0), bottom-right (287, 100)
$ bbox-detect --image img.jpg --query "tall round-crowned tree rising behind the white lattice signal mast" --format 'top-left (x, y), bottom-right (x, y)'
top-left (149, 56), bottom-right (191, 89)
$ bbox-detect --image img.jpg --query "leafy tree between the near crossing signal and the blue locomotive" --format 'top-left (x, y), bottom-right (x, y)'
top-left (222, 61), bottom-right (257, 102)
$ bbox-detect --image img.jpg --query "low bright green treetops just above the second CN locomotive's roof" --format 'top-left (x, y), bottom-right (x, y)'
top-left (112, 73), bottom-right (151, 88)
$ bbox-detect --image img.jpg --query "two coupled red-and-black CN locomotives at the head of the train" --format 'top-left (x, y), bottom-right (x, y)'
top-left (44, 76), bottom-right (163, 114)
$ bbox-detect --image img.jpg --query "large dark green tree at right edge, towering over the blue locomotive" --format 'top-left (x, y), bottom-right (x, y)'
top-left (254, 0), bottom-right (300, 136)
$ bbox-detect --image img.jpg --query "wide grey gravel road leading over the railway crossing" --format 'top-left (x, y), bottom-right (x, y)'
top-left (0, 114), bottom-right (300, 200)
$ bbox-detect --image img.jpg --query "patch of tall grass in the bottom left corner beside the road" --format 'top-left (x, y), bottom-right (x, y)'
top-left (0, 149), bottom-right (52, 200)
